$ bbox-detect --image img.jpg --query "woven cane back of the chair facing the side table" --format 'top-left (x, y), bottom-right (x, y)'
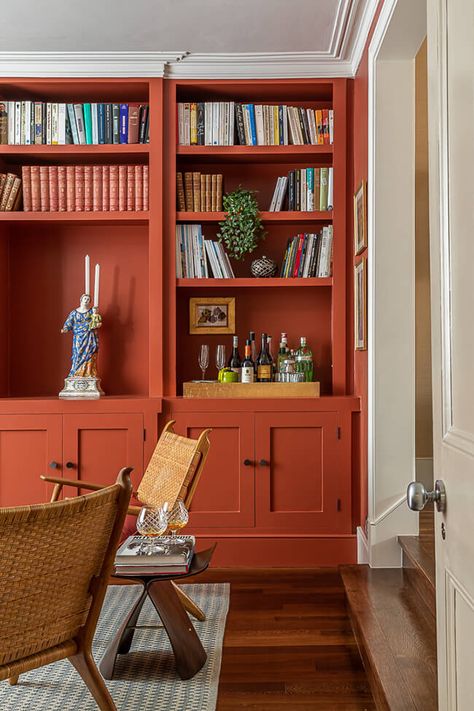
top-left (137, 420), bottom-right (211, 508)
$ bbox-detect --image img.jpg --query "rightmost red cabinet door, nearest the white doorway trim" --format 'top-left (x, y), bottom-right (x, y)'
top-left (255, 412), bottom-right (351, 533)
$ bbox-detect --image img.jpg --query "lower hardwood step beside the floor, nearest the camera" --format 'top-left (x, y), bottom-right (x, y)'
top-left (341, 565), bottom-right (437, 711)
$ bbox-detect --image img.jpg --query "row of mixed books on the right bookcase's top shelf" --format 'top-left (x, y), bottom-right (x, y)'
top-left (178, 101), bottom-right (334, 146)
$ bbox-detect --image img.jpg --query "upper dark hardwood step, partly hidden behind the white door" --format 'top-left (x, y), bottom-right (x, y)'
top-left (398, 536), bottom-right (436, 617)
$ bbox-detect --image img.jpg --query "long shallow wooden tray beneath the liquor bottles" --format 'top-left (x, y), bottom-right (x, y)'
top-left (183, 382), bottom-right (319, 398)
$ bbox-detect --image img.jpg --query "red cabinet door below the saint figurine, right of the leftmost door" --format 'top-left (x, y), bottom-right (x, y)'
top-left (63, 414), bottom-right (143, 496)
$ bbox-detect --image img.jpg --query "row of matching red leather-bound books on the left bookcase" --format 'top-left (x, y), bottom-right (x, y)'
top-left (22, 165), bottom-right (148, 212)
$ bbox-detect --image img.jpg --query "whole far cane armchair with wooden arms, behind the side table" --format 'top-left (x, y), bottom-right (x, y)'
top-left (41, 420), bottom-right (211, 620)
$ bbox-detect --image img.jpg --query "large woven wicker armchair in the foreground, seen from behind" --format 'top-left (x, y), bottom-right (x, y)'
top-left (0, 469), bottom-right (131, 711)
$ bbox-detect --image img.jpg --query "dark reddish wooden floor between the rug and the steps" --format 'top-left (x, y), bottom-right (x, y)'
top-left (196, 569), bottom-right (375, 711)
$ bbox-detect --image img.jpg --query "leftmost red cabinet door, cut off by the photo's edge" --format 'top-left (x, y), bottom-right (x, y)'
top-left (0, 415), bottom-right (62, 506)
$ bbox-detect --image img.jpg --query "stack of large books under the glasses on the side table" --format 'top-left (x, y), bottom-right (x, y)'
top-left (115, 535), bottom-right (196, 576)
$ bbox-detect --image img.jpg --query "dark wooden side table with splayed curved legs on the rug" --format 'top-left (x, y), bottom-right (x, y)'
top-left (103, 544), bottom-right (217, 680)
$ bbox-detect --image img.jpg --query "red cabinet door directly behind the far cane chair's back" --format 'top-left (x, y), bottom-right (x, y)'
top-left (172, 412), bottom-right (255, 528)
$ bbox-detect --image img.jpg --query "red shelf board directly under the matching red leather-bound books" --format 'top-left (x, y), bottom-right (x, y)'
top-left (0, 211), bottom-right (149, 225)
